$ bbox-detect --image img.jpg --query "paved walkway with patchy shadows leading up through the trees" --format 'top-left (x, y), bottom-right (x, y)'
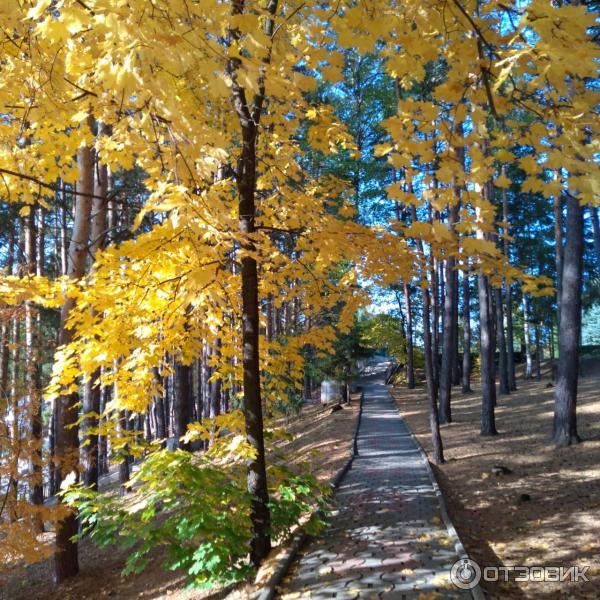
top-left (279, 375), bottom-right (471, 600)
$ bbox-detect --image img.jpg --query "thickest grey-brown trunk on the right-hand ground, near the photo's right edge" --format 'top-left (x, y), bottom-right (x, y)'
top-left (553, 194), bottom-right (583, 447)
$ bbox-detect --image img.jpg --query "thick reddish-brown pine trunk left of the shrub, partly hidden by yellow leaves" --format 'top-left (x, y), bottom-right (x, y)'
top-left (54, 139), bottom-right (94, 583)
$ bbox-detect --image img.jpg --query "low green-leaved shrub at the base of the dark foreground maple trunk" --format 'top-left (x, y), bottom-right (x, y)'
top-left (63, 422), bottom-right (327, 587)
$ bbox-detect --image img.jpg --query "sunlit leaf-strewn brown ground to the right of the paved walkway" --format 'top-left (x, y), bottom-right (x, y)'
top-left (394, 360), bottom-right (600, 600)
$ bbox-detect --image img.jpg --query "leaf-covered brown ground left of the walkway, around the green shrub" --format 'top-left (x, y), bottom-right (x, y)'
top-left (0, 394), bottom-right (359, 600)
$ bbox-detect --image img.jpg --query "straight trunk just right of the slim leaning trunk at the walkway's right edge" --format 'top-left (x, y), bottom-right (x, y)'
top-left (439, 204), bottom-right (458, 424)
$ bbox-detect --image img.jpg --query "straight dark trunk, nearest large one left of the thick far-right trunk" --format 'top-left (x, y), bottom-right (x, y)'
top-left (477, 271), bottom-right (498, 436)
